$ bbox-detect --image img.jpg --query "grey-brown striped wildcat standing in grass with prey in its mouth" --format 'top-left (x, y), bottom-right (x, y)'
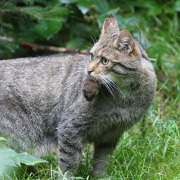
top-left (0, 16), bottom-right (156, 176)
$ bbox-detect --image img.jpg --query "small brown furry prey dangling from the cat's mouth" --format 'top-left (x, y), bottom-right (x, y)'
top-left (82, 76), bottom-right (100, 101)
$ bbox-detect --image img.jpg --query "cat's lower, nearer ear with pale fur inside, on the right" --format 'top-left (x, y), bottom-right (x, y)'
top-left (114, 30), bottom-right (141, 56)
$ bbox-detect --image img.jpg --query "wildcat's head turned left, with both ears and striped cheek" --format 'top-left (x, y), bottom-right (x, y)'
top-left (87, 16), bottom-right (141, 91)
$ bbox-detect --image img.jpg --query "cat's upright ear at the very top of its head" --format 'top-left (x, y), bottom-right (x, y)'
top-left (101, 16), bottom-right (119, 36)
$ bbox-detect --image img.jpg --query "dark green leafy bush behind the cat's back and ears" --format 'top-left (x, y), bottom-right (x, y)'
top-left (0, 0), bottom-right (180, 58)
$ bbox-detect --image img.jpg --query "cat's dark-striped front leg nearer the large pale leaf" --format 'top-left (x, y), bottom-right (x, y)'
top-left (58, 126), bottom-right (83, 174)
